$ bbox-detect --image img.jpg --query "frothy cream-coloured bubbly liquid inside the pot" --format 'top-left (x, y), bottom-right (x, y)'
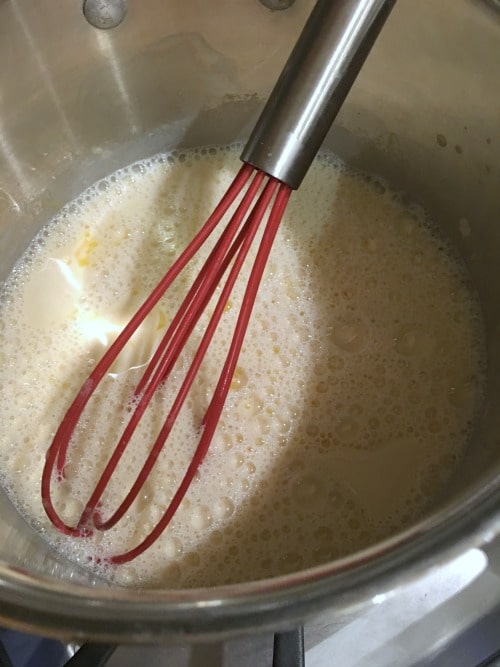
top-left (0, 147), bottom-right (484, 587)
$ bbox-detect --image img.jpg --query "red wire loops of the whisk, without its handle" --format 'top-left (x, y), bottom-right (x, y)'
top-left (42, 164), bottom-right (291, 564)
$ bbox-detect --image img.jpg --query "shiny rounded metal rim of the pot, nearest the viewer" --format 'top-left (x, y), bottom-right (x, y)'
top-left (0, 475), bottom-right (500, 643)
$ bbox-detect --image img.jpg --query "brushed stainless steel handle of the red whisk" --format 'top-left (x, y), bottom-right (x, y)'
top-left (241, 0), bottom-right (396, 189)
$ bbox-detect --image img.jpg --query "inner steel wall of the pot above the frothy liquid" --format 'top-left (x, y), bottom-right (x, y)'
top-left (0, 0), bottom-right (500, 583)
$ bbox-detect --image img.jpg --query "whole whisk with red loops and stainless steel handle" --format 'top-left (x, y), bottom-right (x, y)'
top-left (41, 0), bottom-right (395, 564)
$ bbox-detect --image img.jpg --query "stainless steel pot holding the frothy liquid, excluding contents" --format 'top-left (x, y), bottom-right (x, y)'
top-left (0, 0), bottom-right (500, 642)
